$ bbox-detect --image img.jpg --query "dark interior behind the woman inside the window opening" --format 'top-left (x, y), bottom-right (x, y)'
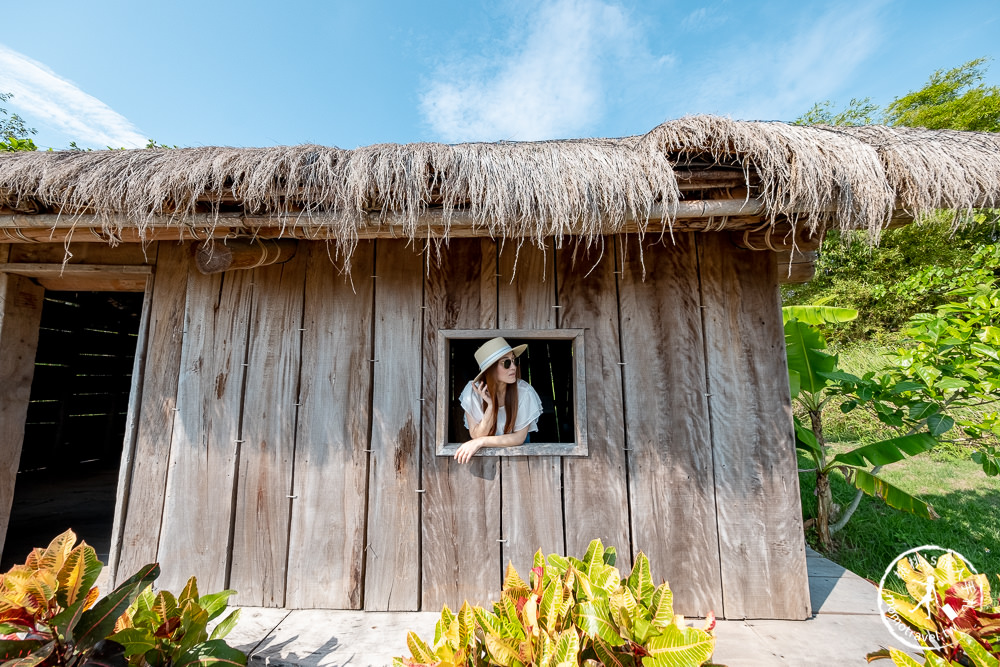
top-left (448, 336), bottom-right (575, 443)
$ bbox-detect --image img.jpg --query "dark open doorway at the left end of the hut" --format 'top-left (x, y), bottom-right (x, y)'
top-left (0, 291), bottom-right (143, 571)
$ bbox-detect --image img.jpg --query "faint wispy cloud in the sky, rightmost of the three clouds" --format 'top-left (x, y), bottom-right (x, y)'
top-left (691, 2), bottom-right (884, 120)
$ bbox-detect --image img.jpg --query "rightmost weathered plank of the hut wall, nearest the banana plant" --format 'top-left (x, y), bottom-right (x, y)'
top-left (698, 234), bottom-right (810, 619)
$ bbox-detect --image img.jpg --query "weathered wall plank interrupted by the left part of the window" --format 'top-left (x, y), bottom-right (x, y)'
top-left (421, 239), bottom-right (501, 610)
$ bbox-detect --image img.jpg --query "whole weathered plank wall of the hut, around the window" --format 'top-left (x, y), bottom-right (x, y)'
top-left (97, 234), bottom-right (808, 618)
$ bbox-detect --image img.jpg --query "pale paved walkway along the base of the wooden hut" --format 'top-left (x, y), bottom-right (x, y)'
top-left (229, 550), bottom-right (899, 667)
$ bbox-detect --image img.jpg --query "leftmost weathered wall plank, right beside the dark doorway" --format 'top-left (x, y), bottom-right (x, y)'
top-left (114, 243), bottom-right (190, 582)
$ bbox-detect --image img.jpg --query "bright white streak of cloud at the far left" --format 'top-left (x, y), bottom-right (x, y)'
top-left (0, 45), bottom-right (146, 148)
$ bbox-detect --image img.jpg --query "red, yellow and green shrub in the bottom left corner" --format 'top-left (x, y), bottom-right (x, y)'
top-left (0, 530), bottom-right (246, 667)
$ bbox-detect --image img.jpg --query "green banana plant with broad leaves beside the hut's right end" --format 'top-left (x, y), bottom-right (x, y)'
top-left (783, 306), bottom-right (940, 550)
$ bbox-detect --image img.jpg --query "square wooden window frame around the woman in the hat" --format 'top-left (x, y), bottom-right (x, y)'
top-left (434, 329), bottom-right (589, 456)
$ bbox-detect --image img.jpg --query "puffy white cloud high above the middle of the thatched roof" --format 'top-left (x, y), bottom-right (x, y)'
top-left (420, 0), bottom-right (660, 142)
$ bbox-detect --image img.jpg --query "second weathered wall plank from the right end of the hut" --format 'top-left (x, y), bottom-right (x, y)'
top-left (620, 234), bottom-right (724, 616)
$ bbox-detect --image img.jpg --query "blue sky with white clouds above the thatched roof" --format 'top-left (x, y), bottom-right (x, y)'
top-left (0, 0), bottom-right (1000, 149)
